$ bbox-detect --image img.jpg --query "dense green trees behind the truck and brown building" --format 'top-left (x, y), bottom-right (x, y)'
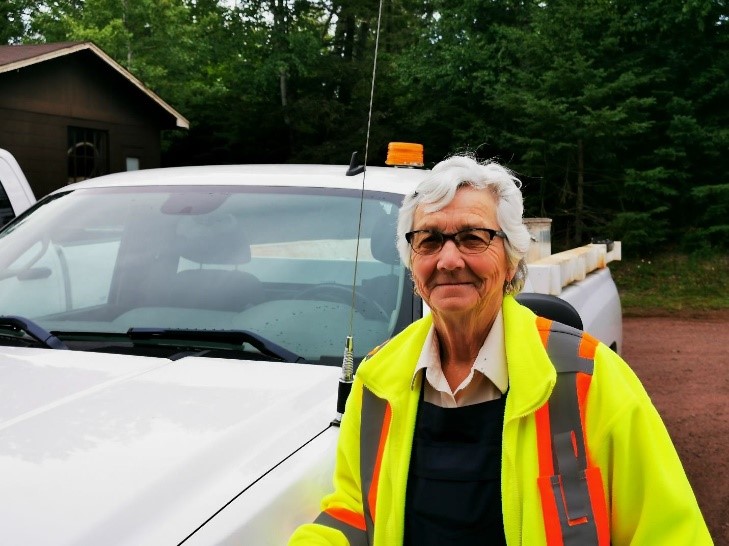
top-left (14, 0), bottom-right (729, 252)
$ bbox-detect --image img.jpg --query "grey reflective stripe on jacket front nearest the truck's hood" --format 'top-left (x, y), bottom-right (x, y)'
top-left (359, 387), bottom-right (387, 541)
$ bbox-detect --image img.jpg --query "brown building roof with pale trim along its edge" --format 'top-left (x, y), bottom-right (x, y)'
top-left (0, 42), bottom-right (190, 129)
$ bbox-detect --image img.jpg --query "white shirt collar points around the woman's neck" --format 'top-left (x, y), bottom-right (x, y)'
top-left (410, 309), bottom-right (509, 394)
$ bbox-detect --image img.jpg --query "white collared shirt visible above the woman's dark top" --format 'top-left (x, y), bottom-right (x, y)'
top-left (412, 310), bottom-right (509, 408)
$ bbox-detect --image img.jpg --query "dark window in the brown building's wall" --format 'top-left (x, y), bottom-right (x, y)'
top-left (68, 127), bottom-right (109, 182)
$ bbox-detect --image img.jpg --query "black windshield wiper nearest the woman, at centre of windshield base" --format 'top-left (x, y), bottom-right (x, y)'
top-left (127, 328), bottom-right (306, 362)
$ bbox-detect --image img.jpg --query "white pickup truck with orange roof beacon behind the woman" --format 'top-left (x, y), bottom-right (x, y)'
top-left (0, 154), bottom-right (622, 546)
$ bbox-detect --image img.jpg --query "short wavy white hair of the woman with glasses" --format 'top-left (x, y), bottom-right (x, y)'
top-left (397, 155), bottom-right (530, 293)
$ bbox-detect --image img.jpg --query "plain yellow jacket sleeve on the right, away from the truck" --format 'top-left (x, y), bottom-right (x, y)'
top-left (587, 346), bottom-right (713, 546)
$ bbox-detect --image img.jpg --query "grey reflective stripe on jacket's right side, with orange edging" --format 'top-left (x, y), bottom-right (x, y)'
top-left (547, 322), bottom-right (598, 546)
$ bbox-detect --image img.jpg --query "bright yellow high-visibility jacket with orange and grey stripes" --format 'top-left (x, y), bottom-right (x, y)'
top-left (289, 296), bottom-right (713, 546)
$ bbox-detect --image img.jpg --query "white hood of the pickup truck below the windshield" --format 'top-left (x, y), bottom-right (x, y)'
top-left (0, 347), bottom-right (339, 545)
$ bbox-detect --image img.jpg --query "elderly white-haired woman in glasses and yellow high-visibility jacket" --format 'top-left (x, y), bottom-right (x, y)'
top-left (290, 156), bottom-right (711, 546)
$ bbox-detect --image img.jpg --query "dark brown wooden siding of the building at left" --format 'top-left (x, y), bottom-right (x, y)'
top-left (0, 51), bottom-right (181, 197)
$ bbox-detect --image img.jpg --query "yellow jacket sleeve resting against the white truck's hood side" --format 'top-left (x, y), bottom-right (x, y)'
top-left (289, 377), bottom-right (368, 546)
